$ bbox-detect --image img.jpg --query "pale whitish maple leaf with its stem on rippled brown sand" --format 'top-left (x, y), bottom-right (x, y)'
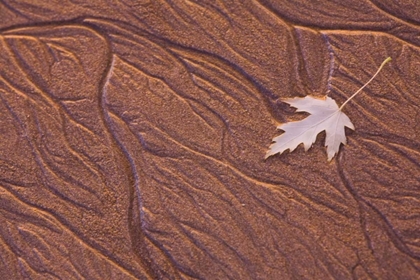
top-left (265, 57), bottom-right (391, 161)
